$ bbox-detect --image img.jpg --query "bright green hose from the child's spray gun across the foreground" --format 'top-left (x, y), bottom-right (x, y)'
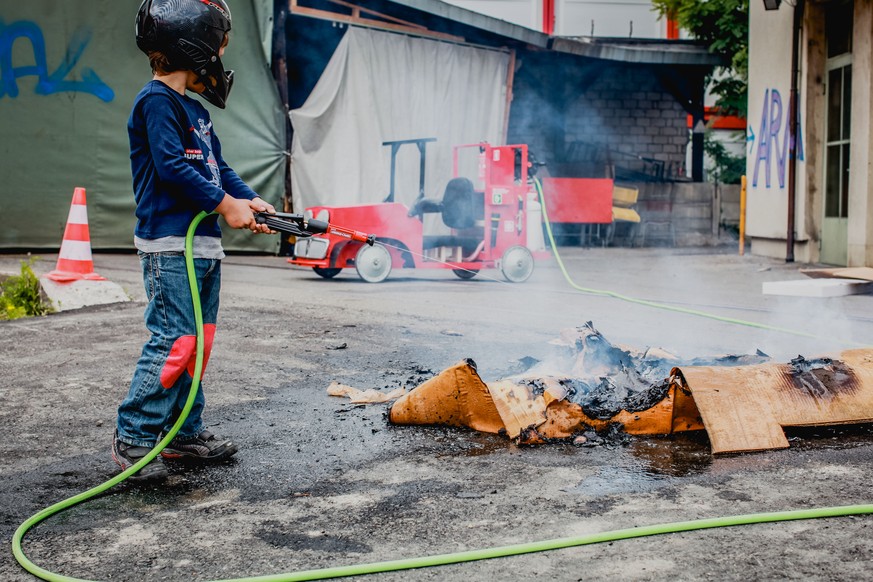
top-left (12, 211), bottom-right (873, 582)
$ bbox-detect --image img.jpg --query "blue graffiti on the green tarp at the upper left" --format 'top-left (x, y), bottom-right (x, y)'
top-left (0, 20), bottom-right (115, 102)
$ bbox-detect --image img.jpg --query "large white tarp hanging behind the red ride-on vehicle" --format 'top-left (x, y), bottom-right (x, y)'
top-left (291, 28), bottom-right (510, 212)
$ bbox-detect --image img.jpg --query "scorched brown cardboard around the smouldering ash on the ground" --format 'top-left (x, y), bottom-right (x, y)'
top-left (389, 328), bottom-right (873, 453)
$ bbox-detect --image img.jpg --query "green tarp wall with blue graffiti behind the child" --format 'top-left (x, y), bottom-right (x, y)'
top-left (0, 0), bottom-right (286, 250)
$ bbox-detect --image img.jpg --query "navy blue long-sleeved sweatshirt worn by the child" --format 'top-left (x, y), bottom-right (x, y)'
top-left (127, 81), bottom-right (257, 239)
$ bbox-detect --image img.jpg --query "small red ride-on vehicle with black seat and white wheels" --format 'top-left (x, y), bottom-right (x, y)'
top-left (288, 138), bottom-right (541, 283)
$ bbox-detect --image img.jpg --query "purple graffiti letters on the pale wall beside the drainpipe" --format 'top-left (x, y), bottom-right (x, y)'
top-left (746, 89), bottom-right (803, 189)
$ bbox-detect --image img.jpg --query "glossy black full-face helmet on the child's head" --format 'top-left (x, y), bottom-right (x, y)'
top-left (136, 0), bottom-right (233, 109)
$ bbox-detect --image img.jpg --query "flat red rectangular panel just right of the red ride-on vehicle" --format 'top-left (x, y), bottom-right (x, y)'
top-left (543, 178), bottom-right (613, 224)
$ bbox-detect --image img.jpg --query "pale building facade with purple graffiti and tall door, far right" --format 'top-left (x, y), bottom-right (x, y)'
top-left (746, 0), bottom-right (873, 267)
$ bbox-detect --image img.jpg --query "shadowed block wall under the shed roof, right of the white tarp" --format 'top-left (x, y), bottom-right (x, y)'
top-left (507, 57), bottom-right (690, 179)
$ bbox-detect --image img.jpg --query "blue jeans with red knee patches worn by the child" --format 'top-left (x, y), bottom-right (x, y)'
top-left (117, 252), bottom-right (221, 447)
